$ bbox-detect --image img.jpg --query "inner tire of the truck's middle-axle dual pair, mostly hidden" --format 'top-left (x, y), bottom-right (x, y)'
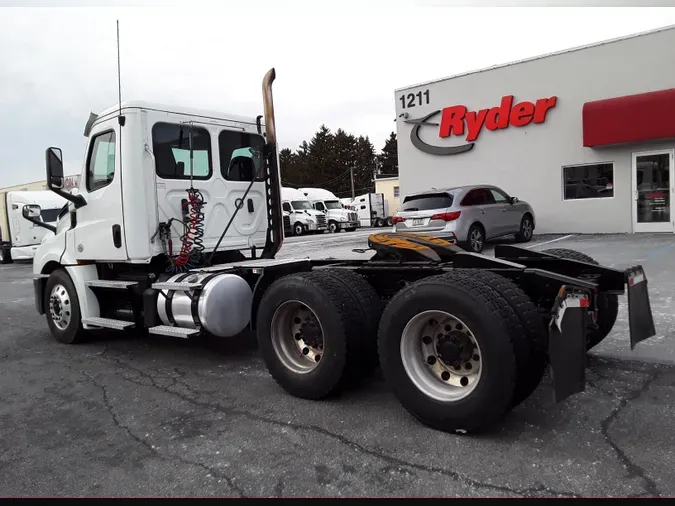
top-left (322, 269), bottom-right (384, 378)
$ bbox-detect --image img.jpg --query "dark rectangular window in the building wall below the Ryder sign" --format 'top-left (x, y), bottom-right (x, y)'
top-left (563, 163), bottom-right (614, 200)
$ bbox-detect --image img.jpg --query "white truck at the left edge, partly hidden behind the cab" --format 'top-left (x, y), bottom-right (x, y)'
top-left (0, 190), bottom-right (67, 264)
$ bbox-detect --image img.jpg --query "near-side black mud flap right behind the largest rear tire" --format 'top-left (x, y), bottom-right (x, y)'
top-left (549, 285), bottom-right (590, 402)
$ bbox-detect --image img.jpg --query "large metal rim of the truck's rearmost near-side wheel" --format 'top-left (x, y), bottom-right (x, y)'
top-left (400, 311), bottom-right (482, 402)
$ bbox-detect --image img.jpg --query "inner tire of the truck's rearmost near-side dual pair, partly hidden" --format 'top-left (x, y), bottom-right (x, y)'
top-left (462, 269), bottom-right (548, 408)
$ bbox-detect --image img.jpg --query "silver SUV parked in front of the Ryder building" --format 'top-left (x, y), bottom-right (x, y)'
top-left (393, 185), bottom-right (535, 253)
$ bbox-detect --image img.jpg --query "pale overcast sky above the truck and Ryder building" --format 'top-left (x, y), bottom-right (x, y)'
top-left (0, 0), bottom-right (675, 187)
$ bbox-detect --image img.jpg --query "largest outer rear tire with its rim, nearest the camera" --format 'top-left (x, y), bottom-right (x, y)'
top-left (378, 272), bottom-right (523, 433)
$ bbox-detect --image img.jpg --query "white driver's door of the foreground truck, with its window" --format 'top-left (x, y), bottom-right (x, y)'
top-left (70, 122), bottom-right (128, 261)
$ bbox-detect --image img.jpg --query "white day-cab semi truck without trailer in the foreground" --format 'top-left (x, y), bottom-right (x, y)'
top-left (29, 69), bottom-right (655, 434)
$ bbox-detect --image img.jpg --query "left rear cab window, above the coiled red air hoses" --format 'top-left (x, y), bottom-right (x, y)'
top-left (152, 123), bottom-right (212, 179)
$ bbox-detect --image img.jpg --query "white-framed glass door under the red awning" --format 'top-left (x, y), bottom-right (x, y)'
top-left (633, 149), bottom-right (675, 232)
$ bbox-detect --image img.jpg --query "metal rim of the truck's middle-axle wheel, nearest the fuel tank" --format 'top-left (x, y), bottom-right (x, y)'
top-left (271, 300), bottom-right (324, 374)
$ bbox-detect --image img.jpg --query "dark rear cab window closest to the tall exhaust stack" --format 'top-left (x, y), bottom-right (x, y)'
top-left (218, 130), bottom-right (265, 181)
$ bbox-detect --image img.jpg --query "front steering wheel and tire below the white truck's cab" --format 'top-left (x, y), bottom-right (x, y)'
top-left (44, 269), bottom-right (86, 344)
